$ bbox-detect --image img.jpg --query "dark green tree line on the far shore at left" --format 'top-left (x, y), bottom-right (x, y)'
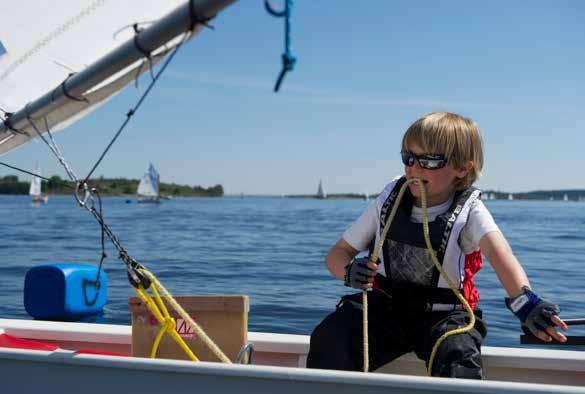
top-left (0, 175), bottom-right (223, 197)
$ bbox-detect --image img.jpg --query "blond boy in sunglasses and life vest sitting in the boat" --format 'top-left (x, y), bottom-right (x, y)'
top-left (307, 112), bottom-right (567, 379)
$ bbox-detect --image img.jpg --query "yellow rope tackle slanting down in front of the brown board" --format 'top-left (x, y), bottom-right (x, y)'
top-left (136, 268), bottom-right (231, 364)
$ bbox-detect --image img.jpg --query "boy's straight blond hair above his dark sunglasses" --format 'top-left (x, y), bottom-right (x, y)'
top-left (402, 112), bottom-right (483, 190)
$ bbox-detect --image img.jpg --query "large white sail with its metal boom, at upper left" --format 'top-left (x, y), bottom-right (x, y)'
top-left (0, 0), bottom-right (234, 154)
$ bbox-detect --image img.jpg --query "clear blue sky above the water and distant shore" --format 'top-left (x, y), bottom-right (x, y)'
top-left (0, 0), bottom-right (585, 194)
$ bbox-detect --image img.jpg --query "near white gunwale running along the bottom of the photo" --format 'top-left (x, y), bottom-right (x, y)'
top-left (0, 348), bottom-right (585, 393)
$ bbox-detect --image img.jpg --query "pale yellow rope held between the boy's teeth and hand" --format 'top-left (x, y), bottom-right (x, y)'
top-left (362, 178), bottom-right (475, 376)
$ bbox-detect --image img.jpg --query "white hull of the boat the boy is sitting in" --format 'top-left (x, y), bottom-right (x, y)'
top-left (0, 319), bottom-right (585, 394)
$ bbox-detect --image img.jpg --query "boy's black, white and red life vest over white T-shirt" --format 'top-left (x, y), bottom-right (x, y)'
top-left (370, 177), bottom-right (482, 311)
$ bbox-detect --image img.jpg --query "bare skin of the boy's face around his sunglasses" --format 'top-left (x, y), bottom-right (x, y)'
top-left (404, 142), bottom-right (469, 207)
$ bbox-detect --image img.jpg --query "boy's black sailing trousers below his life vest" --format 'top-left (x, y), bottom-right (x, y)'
top-left (307, 291), bottom-right (487, 379)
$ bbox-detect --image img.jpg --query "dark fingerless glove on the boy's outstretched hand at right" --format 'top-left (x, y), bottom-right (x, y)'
top-left (506, 286), bottom-right (561, 336)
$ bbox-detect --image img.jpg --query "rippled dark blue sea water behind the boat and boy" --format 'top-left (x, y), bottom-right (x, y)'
top-left (0, 196), bottom-right (585, 346)
